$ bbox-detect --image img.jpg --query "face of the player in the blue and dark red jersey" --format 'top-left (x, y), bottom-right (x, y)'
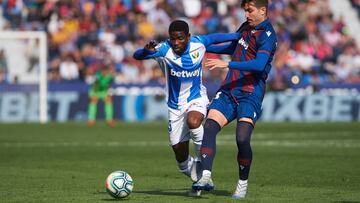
top-left (244, 2), bottom-right (266, 27)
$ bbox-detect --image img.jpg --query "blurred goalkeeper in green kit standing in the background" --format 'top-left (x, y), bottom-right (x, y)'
top-left (88, 65), bottom-right (115, 127)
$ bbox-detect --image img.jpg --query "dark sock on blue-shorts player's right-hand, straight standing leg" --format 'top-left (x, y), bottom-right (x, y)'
top-left (236, 121), bottom-right (254, 180)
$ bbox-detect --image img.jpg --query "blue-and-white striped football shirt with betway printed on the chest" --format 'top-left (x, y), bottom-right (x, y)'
top-left (147, 36), bottom-right (207, 109)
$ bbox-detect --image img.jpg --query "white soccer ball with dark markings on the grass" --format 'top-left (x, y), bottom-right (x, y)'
top-left (105, 171), bottom-right (134, 198)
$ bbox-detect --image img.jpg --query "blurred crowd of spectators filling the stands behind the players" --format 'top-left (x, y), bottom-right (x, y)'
top-left (0, 0), bottom-right (360, 90)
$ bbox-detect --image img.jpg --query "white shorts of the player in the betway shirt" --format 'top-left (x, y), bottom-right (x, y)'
top-left (168, 96), bottom-right (209, 146)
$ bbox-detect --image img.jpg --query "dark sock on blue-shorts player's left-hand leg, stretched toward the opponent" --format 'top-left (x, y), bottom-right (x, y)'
top-left (200, 119), bottom-right (221, 171)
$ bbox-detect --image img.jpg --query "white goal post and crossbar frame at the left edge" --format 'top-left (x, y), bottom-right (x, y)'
top-left (0, 31), bottom-right (48, 123)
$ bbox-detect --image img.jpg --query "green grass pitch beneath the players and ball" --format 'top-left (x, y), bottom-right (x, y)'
top-left (0, 122), bottom-right (360, 203)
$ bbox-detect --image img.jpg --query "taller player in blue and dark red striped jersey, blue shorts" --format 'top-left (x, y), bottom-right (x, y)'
top-left (193, 0), bottom-right (277, 199)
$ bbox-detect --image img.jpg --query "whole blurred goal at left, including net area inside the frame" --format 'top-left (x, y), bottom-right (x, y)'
top-left (0, 31), bottom-right (48, 123)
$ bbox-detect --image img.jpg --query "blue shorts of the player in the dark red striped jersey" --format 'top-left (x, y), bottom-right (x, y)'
top-left (209, 91), bottom-right (262, 124)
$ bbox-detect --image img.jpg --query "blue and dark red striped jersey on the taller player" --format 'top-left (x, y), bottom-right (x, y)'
top-left (221, 19), bottom-right (277, 100)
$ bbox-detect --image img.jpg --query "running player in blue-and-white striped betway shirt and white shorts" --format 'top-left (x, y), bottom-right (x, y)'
top-left (134, 20), bottom-right (239, 195)
